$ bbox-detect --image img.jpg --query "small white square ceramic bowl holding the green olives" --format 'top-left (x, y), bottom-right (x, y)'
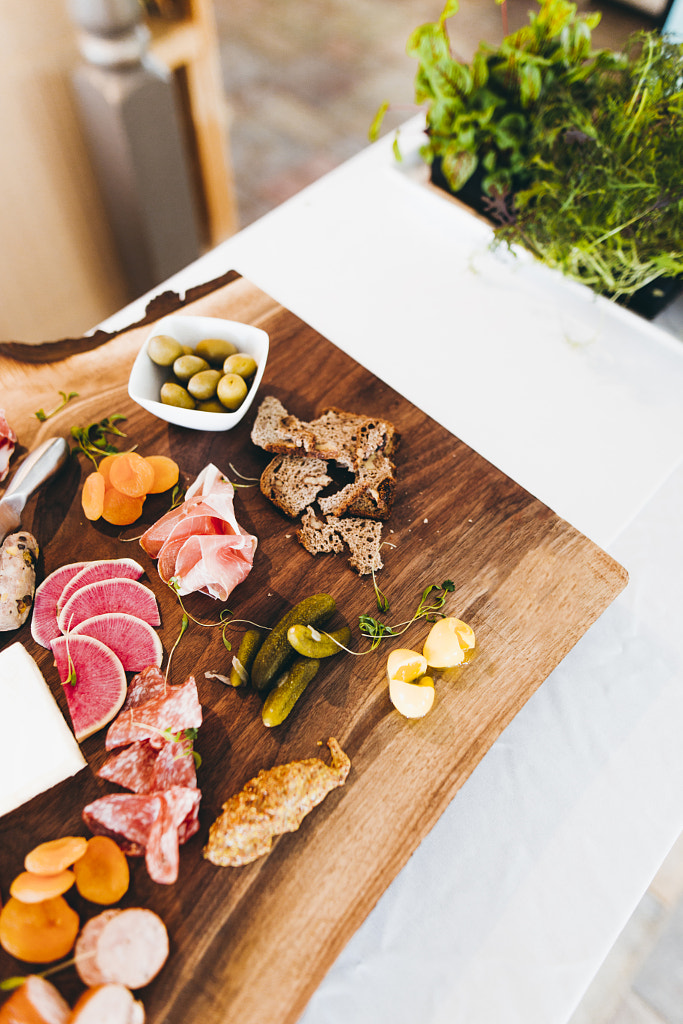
top-left (128, 313), bottom-right (269, 430)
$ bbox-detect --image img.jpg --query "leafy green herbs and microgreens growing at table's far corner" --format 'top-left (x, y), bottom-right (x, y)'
top-left (373, 0), bottom-right (683, 315)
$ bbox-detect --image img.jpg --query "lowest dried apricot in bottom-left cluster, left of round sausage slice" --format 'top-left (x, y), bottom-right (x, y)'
top-left (0, 896), bottom-right (80, 964)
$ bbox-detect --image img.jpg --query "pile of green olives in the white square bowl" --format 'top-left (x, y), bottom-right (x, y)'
top-left (147, 334), bottom-right (257, 413)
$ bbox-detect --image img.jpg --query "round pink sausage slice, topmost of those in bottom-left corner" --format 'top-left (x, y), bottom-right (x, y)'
top-left (75, 907), bottom-right (169, 989)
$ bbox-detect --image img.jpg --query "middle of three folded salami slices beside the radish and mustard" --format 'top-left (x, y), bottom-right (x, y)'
top-left (97, 739), bottom-right (197, 793)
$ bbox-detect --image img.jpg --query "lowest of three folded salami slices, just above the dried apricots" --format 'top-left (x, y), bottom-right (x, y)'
top-left (83, 785), bottom-right (202, 885)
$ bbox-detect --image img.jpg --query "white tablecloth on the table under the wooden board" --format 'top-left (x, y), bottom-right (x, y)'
top-left (101, 121), bottom-right (683, 1024)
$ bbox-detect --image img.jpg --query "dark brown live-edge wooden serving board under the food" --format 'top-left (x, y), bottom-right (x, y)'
top-left (0, 273), bottom-right (627, 1024)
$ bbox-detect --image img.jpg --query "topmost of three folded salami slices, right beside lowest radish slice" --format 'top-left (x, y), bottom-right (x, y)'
top-left (104, 676), bottom-right (202, 751)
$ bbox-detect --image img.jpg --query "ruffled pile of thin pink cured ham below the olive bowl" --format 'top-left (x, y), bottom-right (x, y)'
top-left (140, 463), bottom-right (258, 601)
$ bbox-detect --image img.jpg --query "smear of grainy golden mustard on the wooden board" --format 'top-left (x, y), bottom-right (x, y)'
top-left (204, 736), bottom-right (351, 867)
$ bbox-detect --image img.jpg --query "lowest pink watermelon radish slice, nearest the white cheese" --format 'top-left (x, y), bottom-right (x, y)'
top-left (52, 635), bottom-right (126, 742)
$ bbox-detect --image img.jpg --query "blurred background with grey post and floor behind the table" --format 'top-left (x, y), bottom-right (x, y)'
top-left (0, 0), bottom-right (670, 342)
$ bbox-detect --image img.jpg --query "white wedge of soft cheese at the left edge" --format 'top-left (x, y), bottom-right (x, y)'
top-left (0, 643), bottom-right (87, 815)
